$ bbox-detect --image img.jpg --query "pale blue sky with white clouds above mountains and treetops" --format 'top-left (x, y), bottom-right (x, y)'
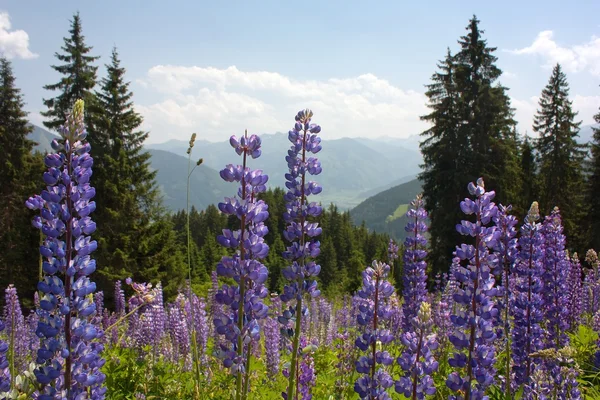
top-left (0, 0), bottom-right (600, 142)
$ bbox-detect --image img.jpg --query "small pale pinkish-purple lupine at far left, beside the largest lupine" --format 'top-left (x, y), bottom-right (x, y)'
top-left (4, 285), bottom-right (30, 376)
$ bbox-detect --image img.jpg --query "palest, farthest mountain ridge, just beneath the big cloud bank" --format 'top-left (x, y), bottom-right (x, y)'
top-left (147, 133), bottom-right (422, 209)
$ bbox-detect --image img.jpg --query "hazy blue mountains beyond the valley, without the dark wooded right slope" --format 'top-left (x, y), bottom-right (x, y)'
top-left (30, 125), bottom-right (421, 210)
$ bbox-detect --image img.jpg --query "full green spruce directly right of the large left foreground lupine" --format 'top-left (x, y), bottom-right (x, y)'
top-left (88, 49), bottom-right (185, 295)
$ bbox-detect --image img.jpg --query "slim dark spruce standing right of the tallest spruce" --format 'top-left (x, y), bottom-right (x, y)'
top-left (533, 64), bottom-right (586, 250)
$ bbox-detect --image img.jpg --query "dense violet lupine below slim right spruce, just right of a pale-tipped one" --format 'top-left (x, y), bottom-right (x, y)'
top-left (542, 207), bottom-right (569, 349)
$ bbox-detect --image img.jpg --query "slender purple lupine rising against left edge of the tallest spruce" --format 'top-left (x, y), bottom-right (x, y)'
top-left (402, 195), bottom-right (427, 331)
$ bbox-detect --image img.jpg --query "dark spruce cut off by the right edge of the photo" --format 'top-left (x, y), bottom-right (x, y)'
top-left (586, 87), bottom-right (600, 250)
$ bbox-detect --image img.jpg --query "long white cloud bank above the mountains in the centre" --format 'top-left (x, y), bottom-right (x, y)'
top-left (137, 65), bottom-right (427, 142)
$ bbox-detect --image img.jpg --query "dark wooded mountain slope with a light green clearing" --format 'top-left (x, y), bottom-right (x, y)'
top-left (350, 179), bottom-right (422, 241)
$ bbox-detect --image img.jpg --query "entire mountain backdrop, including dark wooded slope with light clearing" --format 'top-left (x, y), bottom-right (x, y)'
top-left (30, 125), bottom-right (593, 233)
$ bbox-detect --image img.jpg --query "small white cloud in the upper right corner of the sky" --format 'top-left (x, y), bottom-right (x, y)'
top-left (509, 31), bottom-right (600, 76)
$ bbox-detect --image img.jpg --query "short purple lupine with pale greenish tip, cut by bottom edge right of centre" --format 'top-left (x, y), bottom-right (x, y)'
top-left (396, 302), bottom-right (438, 400)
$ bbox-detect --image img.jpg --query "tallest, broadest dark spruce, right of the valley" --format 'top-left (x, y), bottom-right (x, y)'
top-left (419, 16), bottom-right (521, 274)
